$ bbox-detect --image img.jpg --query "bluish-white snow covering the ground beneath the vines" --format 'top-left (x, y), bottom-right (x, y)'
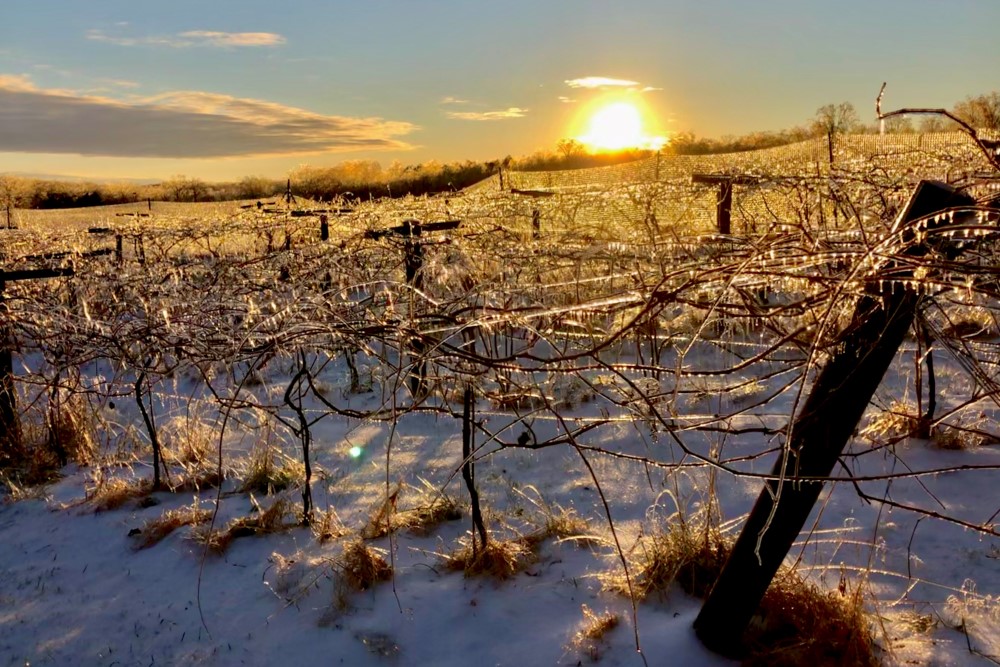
top-left (0, 342), bottom-right (1000, 667)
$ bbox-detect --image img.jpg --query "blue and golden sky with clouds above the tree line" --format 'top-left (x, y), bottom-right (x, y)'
top-left (0, 0), bottom-right (1000, 180)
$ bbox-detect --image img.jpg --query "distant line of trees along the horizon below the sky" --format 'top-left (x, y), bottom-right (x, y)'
top-left (0, 91), bottom-right (1000, 209)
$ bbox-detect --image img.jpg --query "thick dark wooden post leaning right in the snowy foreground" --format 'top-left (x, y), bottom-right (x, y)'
top-left (694, 181), bottom-right (975, 656)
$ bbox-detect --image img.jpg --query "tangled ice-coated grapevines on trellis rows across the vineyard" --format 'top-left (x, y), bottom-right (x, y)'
top-left (3, 128), bottom-right (1000, 660)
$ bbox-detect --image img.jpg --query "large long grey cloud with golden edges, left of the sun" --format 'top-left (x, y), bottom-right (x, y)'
top-left (0, 74), bottom-right (417, 158)
